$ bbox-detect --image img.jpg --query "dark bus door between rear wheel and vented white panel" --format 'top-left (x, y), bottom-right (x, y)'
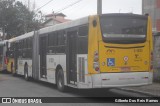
top-left (67, 31), bottom-right (77, 84)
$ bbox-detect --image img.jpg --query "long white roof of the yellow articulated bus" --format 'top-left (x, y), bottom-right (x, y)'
top-left (8, 13), bottom-right (146, 42)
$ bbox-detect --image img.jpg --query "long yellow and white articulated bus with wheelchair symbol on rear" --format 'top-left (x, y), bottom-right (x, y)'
top-left (7, 13), bottom-right (153, 91)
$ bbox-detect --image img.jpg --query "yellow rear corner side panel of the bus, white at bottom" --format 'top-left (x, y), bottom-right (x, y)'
top-left (88, 16), bottom-right (101, 88)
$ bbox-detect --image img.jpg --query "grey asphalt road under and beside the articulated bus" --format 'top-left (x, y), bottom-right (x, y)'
top-left (0, 74), bottom-right (157, 106)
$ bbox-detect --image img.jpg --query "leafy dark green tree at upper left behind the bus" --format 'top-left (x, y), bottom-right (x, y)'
top-left (0, 0), bottom-right (40, 39)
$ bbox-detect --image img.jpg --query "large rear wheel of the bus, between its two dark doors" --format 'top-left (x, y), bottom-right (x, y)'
top-left (56, 69), bottom-right (65, 92)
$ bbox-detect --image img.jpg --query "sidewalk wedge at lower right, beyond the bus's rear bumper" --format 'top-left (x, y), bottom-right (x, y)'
top-left (121, 82), bottom-right (160, 97)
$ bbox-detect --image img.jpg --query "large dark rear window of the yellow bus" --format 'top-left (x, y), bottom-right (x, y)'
top-left (100, 15), bottom-right (147, 44)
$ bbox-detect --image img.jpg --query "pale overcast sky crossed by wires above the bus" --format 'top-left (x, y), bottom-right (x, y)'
top-left (19, 0), bottom-right (142, 20)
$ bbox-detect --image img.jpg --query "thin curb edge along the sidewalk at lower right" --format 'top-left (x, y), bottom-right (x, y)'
top-left (120, 88), bottom-right (160, 97)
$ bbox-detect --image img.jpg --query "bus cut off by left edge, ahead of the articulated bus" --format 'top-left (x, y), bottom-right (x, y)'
top-left (0, 40), bottom-right (7, 72)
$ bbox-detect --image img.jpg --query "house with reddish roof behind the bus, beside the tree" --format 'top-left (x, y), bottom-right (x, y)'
top-left (43, 13), bottom-right (71, 27)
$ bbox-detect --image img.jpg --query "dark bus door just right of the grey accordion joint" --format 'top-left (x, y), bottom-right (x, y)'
top-left (39, 36), bottom-right (47, 78)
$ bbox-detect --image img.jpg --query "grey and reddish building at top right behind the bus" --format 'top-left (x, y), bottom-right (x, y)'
top-left (142, 0), bottom-right (160, 31)
